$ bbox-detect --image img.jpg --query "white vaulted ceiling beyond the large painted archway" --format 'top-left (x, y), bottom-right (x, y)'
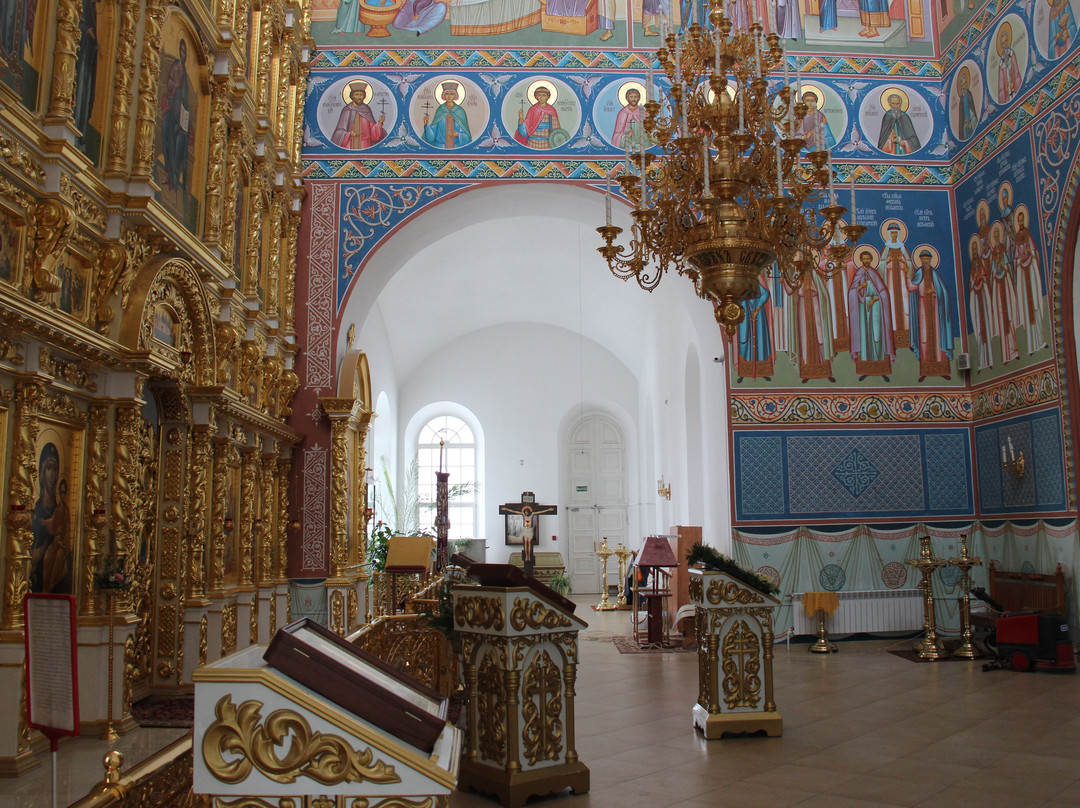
top-left (342, 184), bottom-right (669, 380)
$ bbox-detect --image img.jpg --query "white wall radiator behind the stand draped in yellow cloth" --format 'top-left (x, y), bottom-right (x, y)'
top-left (792, 589), bottom-right (923, 635)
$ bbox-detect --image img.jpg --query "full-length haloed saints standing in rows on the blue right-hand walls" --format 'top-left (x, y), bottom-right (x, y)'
top-left (735, 203), bottom-right (1048, 383)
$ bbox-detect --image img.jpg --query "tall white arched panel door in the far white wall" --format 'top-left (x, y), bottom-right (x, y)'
top-left (567, 413), bottom-right (627, 594)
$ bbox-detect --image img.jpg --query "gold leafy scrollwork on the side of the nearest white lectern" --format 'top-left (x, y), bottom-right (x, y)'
top-left (202, 695), bottom-right (401, 785)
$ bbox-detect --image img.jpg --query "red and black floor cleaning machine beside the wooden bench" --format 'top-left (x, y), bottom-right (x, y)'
top-left (972, 590), bottom-right (1077, 673)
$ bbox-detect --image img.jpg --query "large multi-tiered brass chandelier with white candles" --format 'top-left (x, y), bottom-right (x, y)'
top-left (597, 0), bottom-right (866, 335)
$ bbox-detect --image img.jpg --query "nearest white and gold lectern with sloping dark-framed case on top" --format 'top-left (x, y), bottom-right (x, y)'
top-left (192, 621), bottom-right (462, 808)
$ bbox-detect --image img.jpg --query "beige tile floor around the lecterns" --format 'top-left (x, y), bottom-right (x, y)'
top-left (0, 605), bottom-right (1080, 808)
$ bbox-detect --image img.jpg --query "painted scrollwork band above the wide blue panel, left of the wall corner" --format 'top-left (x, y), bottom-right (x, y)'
top-left (731, 392), bottom-right (972, 426)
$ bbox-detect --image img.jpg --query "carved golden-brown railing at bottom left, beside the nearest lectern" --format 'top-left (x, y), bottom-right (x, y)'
top-left (70, 732), bottom-right (199, 808)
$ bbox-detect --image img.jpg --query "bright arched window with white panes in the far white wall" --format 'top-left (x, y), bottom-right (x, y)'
top-left (416, 415), bottom-right (476, 539)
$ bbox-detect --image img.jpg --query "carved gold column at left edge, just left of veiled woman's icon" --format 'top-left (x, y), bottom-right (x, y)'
top-left (0, 381), bottom-right (45, 630)
